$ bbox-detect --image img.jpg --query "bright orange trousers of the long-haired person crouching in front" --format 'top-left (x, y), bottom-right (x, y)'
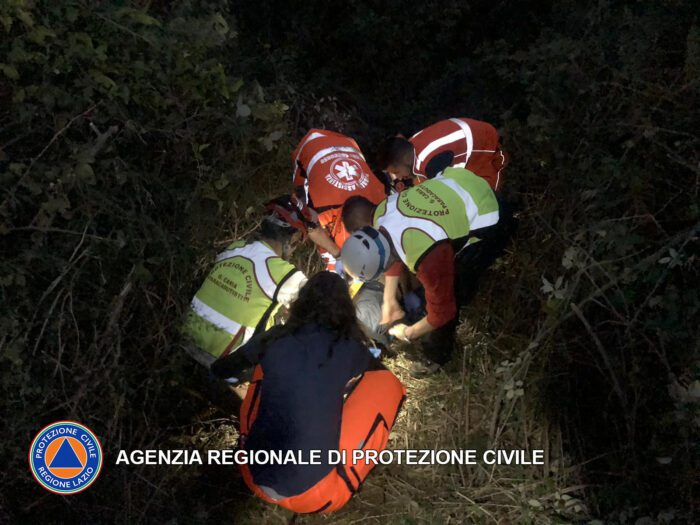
top-left (240, 366), bottom-right (406, 514)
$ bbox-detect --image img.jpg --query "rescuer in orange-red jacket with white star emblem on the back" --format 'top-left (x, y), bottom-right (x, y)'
top-left (292, 128), bottom-right (386, 273)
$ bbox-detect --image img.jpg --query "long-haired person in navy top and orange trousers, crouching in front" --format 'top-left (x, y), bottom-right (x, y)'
top-left (212, 272), bottom-right (406, 513)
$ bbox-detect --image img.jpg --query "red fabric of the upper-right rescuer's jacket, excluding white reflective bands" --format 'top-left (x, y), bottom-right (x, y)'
top-left (410, 118), bottom-right (508, 191)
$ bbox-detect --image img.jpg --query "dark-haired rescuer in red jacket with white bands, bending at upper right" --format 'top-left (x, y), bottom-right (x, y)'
top-left (377, 118), bottom-right (507, 191)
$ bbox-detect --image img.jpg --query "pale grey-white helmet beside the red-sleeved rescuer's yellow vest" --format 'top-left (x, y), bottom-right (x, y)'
top-left (340, 226), bottom-right (391, 281)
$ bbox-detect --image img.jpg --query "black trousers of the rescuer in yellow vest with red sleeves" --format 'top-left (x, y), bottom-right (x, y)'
top-left (420, 199), bottom-right (516, 365)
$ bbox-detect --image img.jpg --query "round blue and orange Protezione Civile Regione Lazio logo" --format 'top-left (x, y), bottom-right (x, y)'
top-left (29, 421), bottom-right (102, 494)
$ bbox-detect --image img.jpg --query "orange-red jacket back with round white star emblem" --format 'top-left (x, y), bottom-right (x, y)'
top-left (292, 128), bottom-right (385, 209)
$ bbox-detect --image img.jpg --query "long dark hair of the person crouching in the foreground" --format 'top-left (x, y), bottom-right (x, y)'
top-left (263, 271), bottom-right (368, 354)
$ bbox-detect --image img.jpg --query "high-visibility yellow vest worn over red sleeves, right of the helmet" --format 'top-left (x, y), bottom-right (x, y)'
top-left (373, 168), bottom-right (498, 272)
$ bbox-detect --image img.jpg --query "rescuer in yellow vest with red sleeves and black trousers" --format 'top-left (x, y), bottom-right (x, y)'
top-left (342, 168), bottom-right (510, 364)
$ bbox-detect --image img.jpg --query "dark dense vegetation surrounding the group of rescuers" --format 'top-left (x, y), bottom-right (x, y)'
top-left (0, 0), bottom-right (700, 523)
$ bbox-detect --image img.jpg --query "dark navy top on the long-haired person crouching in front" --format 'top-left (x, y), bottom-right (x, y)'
top-left (245, 324), bottom-right (371, 496)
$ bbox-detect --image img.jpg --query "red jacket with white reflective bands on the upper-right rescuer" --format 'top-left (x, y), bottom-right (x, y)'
top-left (409, 118), bottom-right (507, 191)
